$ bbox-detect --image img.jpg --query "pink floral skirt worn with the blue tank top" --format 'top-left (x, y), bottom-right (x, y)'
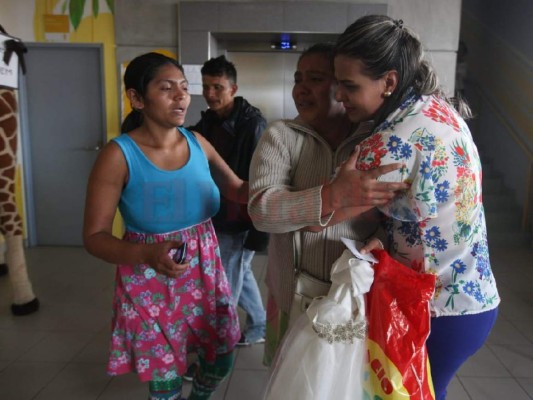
top-left (108, 220), bottom-right (240, 382)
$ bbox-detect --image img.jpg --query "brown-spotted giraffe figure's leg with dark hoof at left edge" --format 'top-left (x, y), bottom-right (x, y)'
top-left (0, 88), bottom-right (39, 315)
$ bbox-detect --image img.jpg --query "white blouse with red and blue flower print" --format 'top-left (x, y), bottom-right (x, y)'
top-left (358, 93), bottom-right (500, 316)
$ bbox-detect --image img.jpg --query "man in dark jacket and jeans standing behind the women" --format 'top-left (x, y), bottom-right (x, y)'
top-left (189, 56), bottom-right (268, 346)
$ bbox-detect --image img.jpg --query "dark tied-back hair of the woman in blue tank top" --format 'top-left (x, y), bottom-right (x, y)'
top-left (120, 52), bottom-right (185, 133)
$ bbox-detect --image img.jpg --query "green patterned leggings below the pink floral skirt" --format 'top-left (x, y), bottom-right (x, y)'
top-left (150, 352), bottom-right (234, 400)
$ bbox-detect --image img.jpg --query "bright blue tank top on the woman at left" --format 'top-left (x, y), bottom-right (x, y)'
top-left (112, 128), bottom-right (220, 233)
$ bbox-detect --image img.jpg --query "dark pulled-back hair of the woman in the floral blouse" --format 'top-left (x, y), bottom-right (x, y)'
top-left (335, 15), bottom-right (471, 125)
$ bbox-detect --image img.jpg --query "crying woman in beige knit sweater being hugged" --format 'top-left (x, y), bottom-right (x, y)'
top-left (248, 44), bottom-right (407, 365)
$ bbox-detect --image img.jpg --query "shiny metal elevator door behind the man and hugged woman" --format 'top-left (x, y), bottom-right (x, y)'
top-left (227, 52), bottom-right (300, 122)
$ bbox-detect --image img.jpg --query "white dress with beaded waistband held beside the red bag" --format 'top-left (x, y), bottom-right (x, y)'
top-left (263, 250), bottom-right (374, 400)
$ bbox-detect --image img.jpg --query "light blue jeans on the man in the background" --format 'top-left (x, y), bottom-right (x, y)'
top-left (217, 232), bottom-right (266, 343)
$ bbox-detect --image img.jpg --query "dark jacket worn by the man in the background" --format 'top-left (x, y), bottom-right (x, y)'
top-left (189, 96), bottom-right (268, 251)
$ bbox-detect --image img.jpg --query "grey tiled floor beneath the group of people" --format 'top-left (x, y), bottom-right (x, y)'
top-left (0, 242), bottom-right (533, 400)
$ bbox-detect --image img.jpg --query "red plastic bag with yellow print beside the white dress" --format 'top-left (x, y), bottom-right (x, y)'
top-left (364, 250), bottom-right (436, 400)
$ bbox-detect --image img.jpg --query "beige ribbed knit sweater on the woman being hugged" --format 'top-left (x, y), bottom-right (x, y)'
top-left (248, 120), bottom-right (381, 313)
